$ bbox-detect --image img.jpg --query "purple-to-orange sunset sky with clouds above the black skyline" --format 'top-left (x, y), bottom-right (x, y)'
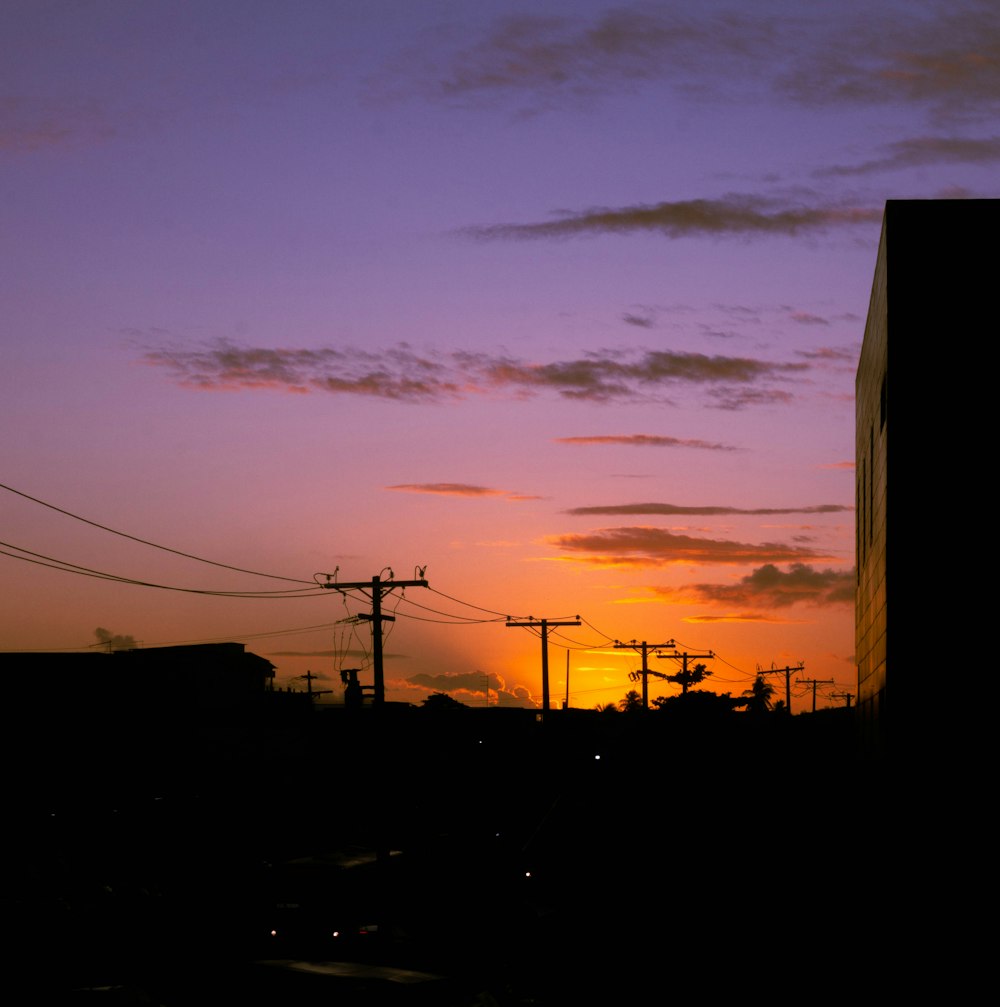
top-left (0, 0), bottom-right (1000, 712)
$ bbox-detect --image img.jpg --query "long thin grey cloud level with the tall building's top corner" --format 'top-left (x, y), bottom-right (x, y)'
top-left (461, 193), bottom-right (883, 241)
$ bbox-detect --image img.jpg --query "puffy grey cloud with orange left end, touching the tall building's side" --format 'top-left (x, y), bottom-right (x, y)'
top-left (654, 563), bottom-right (855, 609)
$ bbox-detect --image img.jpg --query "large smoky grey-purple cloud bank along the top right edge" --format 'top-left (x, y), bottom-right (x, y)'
top-left (391, 0), bottom-right (1000, 127)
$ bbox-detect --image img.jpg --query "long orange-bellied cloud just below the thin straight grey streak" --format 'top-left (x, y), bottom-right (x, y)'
top-left (546, 526), bottom-right (827, 567)
